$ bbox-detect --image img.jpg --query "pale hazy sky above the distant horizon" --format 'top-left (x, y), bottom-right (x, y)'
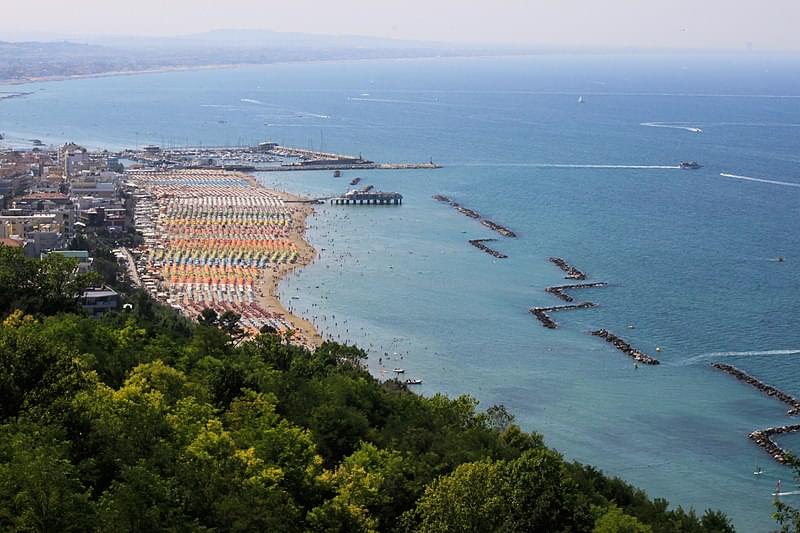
top-left (0, 0), bottom-right (800, 50)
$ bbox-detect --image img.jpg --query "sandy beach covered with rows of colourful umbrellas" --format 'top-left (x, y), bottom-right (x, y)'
top-left (128, 170), bottom-right (320, 346)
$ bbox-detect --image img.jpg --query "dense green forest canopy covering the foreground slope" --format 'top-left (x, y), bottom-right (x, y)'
top-left (0, 247), bottom-right (733, 533)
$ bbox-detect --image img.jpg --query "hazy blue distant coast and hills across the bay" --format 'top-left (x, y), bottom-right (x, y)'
top-left (0, 30), bottom-right (504, 82)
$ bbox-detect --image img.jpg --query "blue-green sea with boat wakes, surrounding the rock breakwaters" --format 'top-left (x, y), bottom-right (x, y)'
top-left (0, 53), bottom-right (800, 532)
